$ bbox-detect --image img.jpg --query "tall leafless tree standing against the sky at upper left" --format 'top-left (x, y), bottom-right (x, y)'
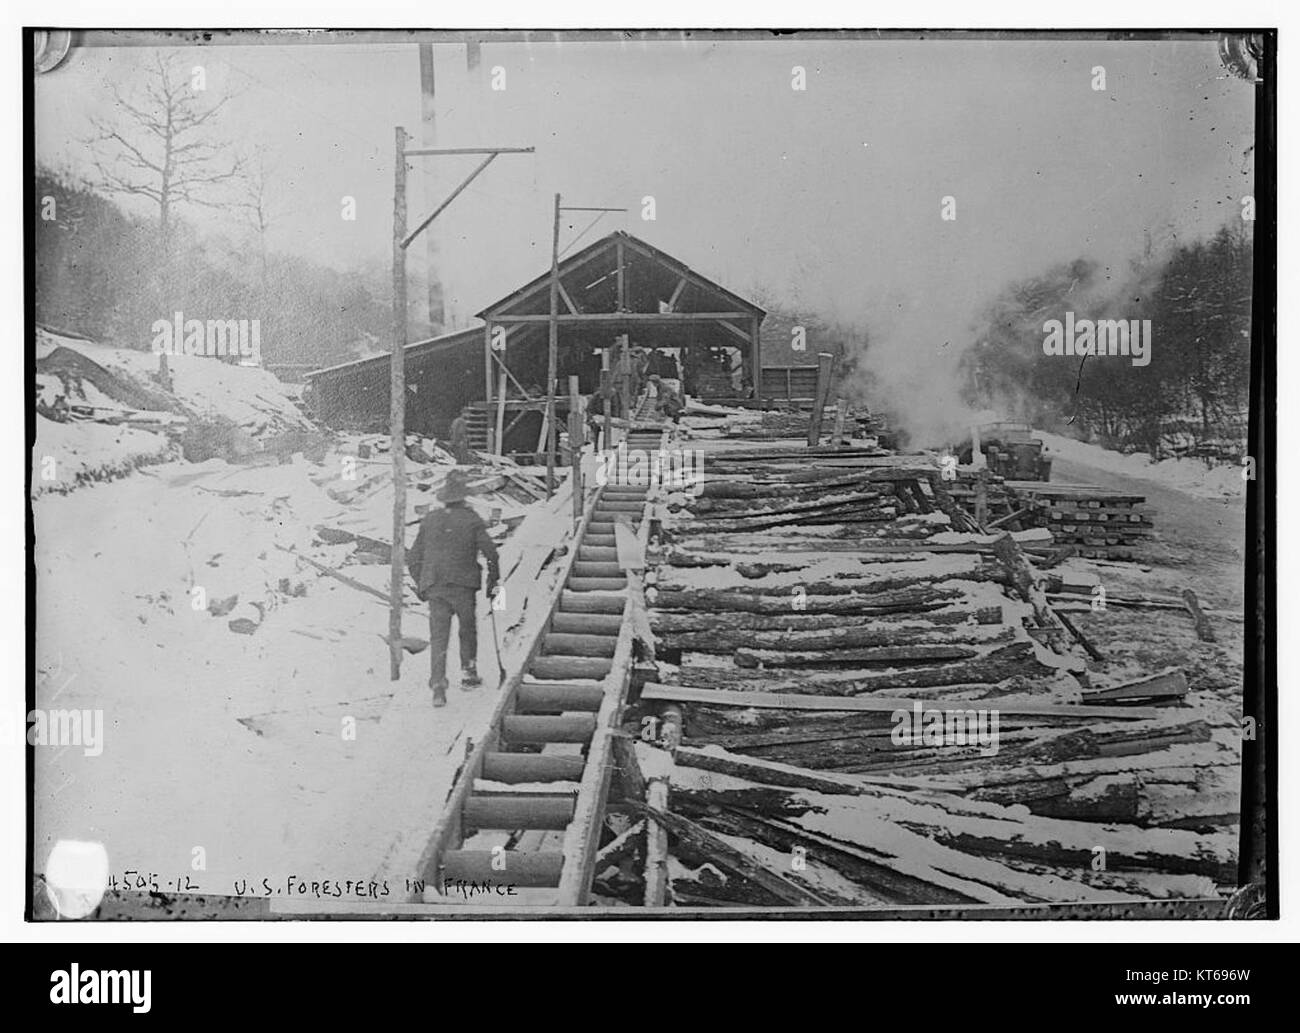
top-left (90, 53), bottom-right (243, 257)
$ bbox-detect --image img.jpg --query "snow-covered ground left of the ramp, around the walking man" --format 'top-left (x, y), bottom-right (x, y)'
top-left (33, 339), bottom-right (572, 902)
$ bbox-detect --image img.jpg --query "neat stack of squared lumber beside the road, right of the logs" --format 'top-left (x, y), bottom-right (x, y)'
top-left (1006, 481), bottom-right (1154, 560)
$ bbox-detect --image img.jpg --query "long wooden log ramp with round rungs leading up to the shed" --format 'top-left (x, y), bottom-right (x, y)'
top-left (416, 427), bottom-right (663, 907)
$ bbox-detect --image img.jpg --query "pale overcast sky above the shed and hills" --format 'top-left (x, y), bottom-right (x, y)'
top-left (36, 31), bottom-right (1253, 335)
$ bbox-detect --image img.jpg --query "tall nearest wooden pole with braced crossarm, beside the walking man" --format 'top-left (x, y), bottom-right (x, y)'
top-left (389, 139), bottom-right (533, 681)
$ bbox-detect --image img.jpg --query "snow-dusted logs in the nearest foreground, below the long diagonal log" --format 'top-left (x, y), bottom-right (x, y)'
top-left (636, 747), bottom-right (1236, 907)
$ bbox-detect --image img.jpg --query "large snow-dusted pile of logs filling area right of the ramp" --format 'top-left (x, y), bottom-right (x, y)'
top-left (621, 446), bottom-right (1239, 907)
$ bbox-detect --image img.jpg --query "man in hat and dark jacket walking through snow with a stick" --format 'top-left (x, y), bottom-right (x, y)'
top-left (407, 470), bottom-right (501, 707)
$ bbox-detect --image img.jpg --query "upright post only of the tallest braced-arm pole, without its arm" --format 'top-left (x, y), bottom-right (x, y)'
top-left (389, 126), bottom-right (406, 681)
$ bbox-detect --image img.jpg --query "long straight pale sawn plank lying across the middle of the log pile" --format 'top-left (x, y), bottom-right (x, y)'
top-left (641, 682), bottom-right (1161, 721)
